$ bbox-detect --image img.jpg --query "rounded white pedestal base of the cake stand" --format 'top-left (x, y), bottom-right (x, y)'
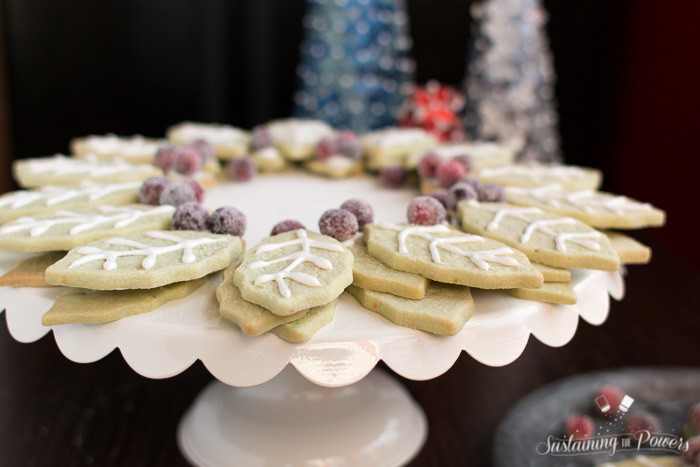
top-left (178, 366), bottom-right (427, 467)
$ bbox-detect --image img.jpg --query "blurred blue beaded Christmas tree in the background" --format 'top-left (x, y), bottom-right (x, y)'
top-left (294, 0), bottom-right (415, 132)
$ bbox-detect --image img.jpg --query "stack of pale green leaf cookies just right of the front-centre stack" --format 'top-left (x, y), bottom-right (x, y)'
top-left (348, 223), bottom-right (542, 335)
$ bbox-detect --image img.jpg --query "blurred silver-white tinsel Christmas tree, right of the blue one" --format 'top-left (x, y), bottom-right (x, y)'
top-left (465, 0), bottom-right (561, 162)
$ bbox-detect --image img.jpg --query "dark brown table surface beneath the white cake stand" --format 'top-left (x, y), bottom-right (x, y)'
top-left (0, 232), bottom-right (700, 466)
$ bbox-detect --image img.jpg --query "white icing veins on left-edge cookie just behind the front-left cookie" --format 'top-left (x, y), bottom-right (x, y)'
top-left (0, 206), bottom-right (175, 237)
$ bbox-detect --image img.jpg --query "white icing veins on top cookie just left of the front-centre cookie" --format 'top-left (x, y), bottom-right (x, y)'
top-left (68, 230), bottom-right (226, 271)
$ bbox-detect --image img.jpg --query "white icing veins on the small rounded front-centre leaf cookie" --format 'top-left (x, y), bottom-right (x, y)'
top-left (248, 229), bottom-right (343, 298)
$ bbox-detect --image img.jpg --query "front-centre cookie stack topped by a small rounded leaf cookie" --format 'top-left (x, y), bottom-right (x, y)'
top-left (216, 229), bottom-right (353, 342)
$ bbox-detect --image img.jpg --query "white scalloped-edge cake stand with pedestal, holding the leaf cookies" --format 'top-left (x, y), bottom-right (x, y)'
top-left (0, 173), bottom-right (623, 466)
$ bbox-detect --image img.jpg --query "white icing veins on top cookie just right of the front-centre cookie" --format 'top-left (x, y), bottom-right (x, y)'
top-left (378, 224), bottom-right (520, 271)
